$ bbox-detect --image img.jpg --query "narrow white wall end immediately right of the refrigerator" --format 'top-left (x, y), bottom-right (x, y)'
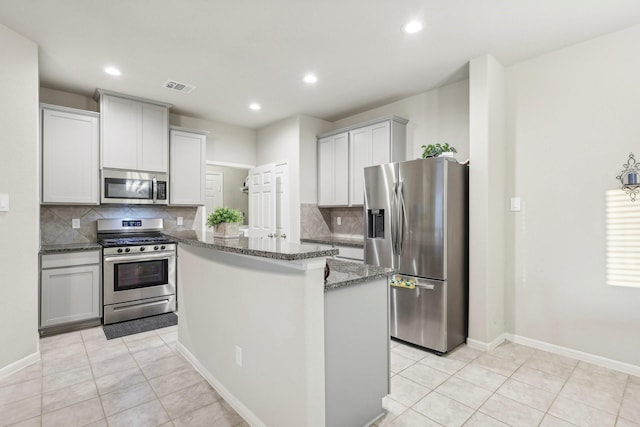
top-left (469, 55), bottom-right (505, 346)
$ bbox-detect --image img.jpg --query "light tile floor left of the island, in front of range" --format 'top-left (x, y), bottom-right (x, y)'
top-left (0, 326), bottom-right (248, 427)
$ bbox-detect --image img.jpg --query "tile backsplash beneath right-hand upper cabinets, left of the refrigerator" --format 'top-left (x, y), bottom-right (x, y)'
top-left (300, 203), bottom-right (364, 239)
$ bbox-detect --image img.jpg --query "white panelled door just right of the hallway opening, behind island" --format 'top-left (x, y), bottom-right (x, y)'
top-left (249, 163), bottom-right (276, 237)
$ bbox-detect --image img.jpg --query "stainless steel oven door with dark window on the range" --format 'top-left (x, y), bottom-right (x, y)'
top-left (103, 252), bottom-right (176, 305)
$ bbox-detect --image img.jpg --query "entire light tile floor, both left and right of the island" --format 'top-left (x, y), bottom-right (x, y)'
top-left (0, 326), bottom-right (640, 427)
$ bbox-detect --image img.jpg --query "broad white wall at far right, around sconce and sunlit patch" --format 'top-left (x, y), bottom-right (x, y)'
top-left (504, 26), bottom-right (640, 366)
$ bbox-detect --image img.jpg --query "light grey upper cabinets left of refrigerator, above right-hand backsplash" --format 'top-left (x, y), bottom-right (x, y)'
top-left (318, 116), bottom-right (408, 206)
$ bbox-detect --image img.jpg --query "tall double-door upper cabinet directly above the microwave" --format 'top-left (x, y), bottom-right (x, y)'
top-left (98, 89), bottom-right (171, 173)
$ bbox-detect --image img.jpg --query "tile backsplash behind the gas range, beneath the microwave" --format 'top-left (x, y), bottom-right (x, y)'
top-left (40, 205), bottom-right (198, 245)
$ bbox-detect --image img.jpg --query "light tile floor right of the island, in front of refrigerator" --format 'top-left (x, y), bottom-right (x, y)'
top-left (375, 341), bottom-right (640, 427)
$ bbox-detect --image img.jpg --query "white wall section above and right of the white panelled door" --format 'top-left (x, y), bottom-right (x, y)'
top-left (256, 116), bottom-right (300, 241)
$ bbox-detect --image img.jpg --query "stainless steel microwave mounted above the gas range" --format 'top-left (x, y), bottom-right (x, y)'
top-left (100, 169), bottom-right (169, 205)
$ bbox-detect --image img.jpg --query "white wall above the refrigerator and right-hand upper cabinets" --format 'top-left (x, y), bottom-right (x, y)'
top-left (333, 80), bottom-right (469, 161)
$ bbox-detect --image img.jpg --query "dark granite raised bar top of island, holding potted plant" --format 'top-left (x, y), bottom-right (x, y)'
top-left (165, 230), bottom-right (338, 261)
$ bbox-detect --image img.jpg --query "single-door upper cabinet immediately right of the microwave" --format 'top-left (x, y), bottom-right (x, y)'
top-left (169, 126), bottom-right (208, 206)
